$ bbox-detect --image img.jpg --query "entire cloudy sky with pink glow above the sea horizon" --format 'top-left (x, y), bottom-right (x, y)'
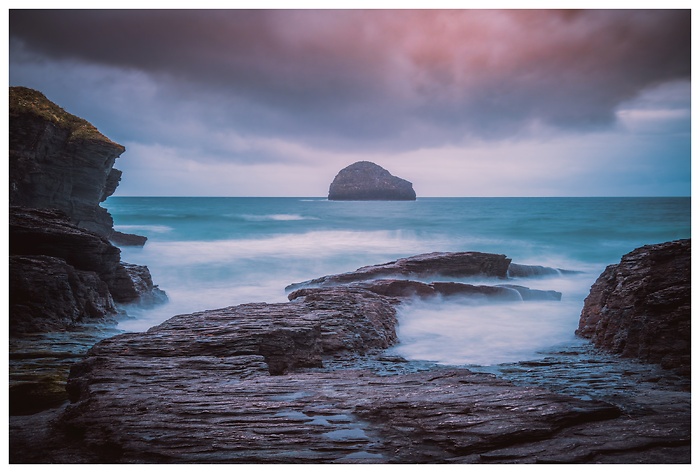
top-left (9, 9), bottom-right (691, 197)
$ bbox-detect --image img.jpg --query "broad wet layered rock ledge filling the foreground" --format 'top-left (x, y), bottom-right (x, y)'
top-left (10, 287), bottom-right (690, 463)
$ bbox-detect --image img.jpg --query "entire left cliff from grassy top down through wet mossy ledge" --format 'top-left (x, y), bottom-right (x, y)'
top-left (8, 87), bottom-right (166, 414)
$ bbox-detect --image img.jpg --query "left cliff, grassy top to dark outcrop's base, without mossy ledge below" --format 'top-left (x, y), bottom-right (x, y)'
top-left (9, 87), bottom-right (164, 335)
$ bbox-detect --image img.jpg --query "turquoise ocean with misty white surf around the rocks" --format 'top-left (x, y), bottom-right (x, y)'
top-left (108, 197), bottom-right (691, 366)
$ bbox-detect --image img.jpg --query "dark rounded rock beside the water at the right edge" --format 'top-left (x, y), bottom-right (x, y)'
top-left (576, 240), bottom-right (691, 376)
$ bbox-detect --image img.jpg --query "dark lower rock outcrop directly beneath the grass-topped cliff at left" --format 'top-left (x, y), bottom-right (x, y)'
top-left (9, 207), bottom-right (165, 335)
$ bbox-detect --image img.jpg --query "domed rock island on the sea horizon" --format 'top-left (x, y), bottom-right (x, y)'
top-left (328, 161), bottom-right (416, 200)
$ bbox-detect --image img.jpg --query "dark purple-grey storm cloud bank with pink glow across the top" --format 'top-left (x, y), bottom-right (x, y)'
top-left (10, 10), bottom-right (691, 147)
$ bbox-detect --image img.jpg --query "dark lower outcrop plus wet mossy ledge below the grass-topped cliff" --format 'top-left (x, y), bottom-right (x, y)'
top-left (8, 207), bottom-right (166, 413)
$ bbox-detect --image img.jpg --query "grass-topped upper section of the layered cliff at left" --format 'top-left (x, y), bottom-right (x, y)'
top-left (9, 87), bottom-right (145, 245)
